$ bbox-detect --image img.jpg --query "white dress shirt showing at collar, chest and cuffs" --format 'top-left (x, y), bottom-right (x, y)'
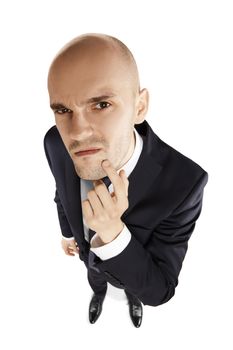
top-left (63, 128), bottom-right (143, 260)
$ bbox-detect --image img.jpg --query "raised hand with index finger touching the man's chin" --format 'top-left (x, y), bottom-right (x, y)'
top-left (82, 161), bottom-right (129, 244)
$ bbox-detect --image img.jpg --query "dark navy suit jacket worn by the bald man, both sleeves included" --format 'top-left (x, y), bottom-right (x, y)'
top-left (44, 120), bottom-right (208, 306)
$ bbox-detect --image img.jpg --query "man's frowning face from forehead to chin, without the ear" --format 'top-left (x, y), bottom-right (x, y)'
top-left (48, 48), bottom-right (147, 180)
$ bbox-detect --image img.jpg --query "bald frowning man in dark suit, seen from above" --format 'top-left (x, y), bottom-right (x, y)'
top-left (44, 33), bottom-right (208, 327)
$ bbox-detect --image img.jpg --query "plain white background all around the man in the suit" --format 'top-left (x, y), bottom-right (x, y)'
top-left (0, 0), bottom-right (233, 350)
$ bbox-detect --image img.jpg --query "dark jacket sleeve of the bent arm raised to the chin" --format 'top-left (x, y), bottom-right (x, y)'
top-left (96, 172), bottom-right (208, 306)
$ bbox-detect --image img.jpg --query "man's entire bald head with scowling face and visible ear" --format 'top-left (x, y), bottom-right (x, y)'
top-left (48, 33), bottom-right (148, 180)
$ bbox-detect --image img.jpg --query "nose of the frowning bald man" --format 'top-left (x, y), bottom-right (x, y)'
top-left (69, 111), bottom-right (93, 141)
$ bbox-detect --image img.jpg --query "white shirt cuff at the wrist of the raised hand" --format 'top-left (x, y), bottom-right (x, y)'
top-left (90, 225), bottom-right (131, 260)
